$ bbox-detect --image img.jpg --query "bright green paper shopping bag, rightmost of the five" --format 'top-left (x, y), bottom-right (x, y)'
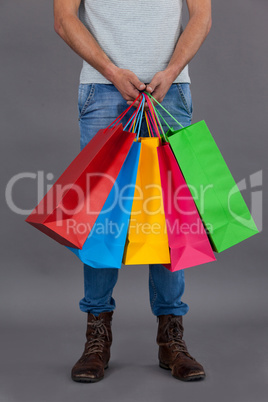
top-left (148, 93), bottom-right (258, 252)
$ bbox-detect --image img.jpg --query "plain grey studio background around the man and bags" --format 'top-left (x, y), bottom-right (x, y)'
top-left (0, 0), bottom-right (268, 402)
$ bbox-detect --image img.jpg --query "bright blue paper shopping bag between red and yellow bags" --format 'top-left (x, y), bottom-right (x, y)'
top-left (67, 141), bottom-right (141, 268)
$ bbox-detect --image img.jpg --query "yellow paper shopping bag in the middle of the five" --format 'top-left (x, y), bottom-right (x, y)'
top-left (123, 137), bottom-right (170, 265)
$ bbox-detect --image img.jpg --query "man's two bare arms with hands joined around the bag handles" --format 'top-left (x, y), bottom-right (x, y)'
top-left (54, 0), bottom-right (211, 110)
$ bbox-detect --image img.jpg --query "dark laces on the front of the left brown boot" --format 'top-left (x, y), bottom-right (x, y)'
top-left (82, 319), bottom-right (109, 360)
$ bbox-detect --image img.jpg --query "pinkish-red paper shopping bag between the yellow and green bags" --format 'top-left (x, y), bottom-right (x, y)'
top-left (157, 143), bottom-right (216, 272)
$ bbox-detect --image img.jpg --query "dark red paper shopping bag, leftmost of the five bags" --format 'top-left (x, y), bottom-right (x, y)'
top-left (26, 124), bottom-right (136, 249)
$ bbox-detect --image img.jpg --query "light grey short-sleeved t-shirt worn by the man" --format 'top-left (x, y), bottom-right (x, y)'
top-left (79, 0), bottom-right (190, 84)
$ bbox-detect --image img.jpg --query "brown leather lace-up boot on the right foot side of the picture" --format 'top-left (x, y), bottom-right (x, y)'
top-left (156, 314), bottom-right (206, 381)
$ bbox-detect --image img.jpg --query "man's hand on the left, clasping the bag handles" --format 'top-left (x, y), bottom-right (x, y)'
top-left (111, 67), bottom-right (146, 105)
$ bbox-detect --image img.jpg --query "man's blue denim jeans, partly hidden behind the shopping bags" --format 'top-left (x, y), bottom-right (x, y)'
top-left (78, 84), bottom-right (192, 316)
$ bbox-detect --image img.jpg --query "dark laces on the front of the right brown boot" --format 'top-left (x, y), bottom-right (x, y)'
top-left (164, 317), bottom-right (195, 360)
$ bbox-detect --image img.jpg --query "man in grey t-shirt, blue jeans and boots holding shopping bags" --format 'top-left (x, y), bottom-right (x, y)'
top-left (54, 0), bottom-right (211, 382)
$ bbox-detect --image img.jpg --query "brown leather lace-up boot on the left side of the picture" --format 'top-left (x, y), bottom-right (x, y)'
top-left (72, 311), bottom-right (113, 382)
